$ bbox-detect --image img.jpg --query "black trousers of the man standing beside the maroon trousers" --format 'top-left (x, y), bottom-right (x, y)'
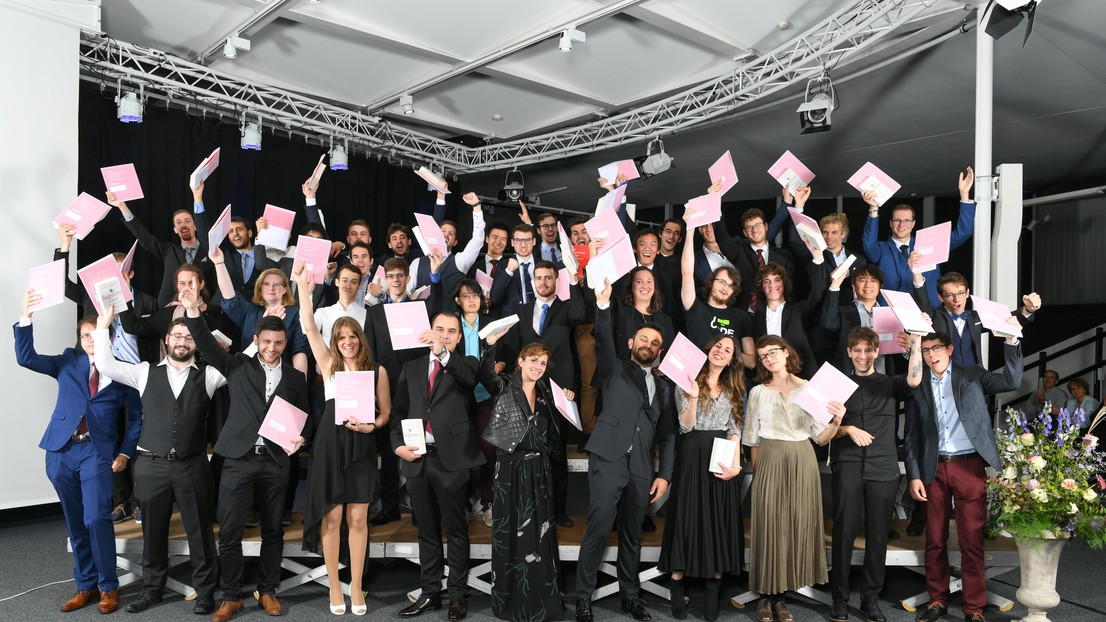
top-left (830, 463), bottom-right (898, 602)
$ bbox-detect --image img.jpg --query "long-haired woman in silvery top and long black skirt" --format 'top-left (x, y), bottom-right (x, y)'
top-left (659, 335), bottom-right (745, 621)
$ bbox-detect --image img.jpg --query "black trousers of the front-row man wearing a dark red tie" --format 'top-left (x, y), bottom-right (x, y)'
top-left (407, 452), bottom-right (471, 599)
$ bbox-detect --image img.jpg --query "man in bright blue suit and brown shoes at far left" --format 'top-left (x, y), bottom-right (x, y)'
top-left (15, 290), bottom-right (142, 613)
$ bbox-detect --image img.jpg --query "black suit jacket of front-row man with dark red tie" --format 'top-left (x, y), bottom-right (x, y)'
top-left (392, 352), bottom-right (487, 477)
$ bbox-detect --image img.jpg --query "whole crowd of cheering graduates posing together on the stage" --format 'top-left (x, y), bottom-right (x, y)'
top-left (14, 158), bottom-right (1057, 622)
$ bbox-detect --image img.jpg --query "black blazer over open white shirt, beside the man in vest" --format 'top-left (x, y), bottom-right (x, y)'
top-left (185, 317), bottom-right (313, 466)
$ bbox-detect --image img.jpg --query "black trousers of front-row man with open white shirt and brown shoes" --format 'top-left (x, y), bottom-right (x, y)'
top-left (219, 453), bottom-right (288, 600)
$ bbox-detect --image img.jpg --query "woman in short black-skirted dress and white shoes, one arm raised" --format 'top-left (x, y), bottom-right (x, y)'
top-left (293, 262), bottom-right (392, 615)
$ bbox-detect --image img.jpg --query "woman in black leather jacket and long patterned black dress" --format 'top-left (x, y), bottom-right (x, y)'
top-left (480, 332), bottom-right (574, 622)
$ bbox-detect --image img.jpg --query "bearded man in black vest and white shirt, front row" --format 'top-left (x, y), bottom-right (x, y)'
top-left (92, 307), bottom-right (227, 614)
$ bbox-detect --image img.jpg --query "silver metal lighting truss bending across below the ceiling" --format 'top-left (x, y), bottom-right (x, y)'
top-left (80, 0), bottom-right (935, 174)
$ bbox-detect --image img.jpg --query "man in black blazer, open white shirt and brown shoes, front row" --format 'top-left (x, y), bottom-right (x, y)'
top-left (181, 296), bottom-right (311, 622)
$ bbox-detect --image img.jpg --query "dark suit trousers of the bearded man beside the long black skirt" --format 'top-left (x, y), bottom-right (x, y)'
top-left (576, 454), bottom-right (653, 599)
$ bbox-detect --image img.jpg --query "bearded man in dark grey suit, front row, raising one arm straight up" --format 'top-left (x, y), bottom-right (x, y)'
top-left (576, 281), bottom-right (676, 622)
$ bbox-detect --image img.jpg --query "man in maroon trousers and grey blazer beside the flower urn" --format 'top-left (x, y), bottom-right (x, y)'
top-left (902, 325), bottom-right (1022, 622)
